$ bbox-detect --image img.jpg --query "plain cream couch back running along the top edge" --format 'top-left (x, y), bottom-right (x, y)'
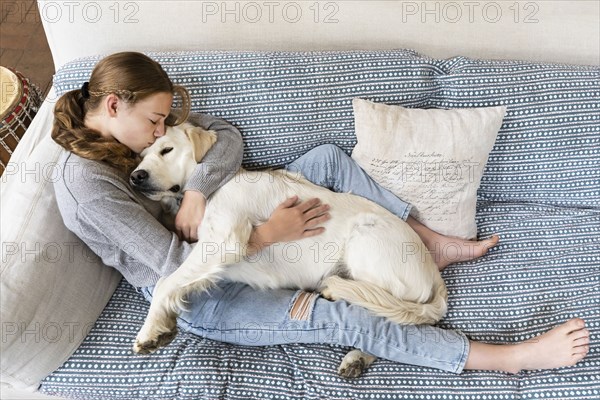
top-left (38, 0), bottom-right (600, 69)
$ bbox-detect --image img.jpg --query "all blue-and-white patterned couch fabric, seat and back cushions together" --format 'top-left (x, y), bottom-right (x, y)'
top-left (41, 51), bottom-right (600, 400)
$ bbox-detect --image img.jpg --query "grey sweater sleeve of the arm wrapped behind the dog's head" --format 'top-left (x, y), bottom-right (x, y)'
top-left (183, 114), bottom-right (244, 198)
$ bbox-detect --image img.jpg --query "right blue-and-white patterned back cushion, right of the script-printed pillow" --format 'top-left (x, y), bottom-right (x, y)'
top-left (431, 57), bottom-right (600, 207)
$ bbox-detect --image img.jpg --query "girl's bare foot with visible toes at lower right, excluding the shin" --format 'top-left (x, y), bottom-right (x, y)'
top-left (510, 318), bottom-right (590, 373)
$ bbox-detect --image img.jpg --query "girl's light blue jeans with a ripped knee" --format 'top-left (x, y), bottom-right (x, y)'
top-left (142, 145), bottom-right (469, 373)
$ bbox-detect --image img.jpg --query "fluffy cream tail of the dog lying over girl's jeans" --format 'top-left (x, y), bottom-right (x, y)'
top-left (323, 276), bottom-right (448, 325)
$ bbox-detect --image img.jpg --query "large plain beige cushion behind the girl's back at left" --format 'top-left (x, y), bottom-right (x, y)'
top-left (0, 97), bottom-right (120, 390)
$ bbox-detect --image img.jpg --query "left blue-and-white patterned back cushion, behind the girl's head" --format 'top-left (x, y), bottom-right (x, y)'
top-left (54, 50), bottom-right (440, 169)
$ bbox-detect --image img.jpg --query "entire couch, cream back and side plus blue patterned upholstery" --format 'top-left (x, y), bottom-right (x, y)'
top-left (0, 0), bottom-right (600, 400)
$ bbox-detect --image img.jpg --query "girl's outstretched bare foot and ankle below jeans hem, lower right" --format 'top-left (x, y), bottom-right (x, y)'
top-left (464, 318), bottom-right (590, 374)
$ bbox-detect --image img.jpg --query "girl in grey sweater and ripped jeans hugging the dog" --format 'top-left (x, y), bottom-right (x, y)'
top-left (52, 52), bottom-right (589, 373)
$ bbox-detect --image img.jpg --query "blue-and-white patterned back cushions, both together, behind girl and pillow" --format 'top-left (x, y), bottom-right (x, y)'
top-left (55, 50), bottom-right (600, 207)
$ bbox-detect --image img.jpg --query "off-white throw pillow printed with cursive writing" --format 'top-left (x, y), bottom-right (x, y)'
top-left (352, 99), bottom-right (506, 239)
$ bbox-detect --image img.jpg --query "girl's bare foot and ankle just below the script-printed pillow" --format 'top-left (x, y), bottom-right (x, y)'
top-left (406, 217), bottom-right (500, 271)
